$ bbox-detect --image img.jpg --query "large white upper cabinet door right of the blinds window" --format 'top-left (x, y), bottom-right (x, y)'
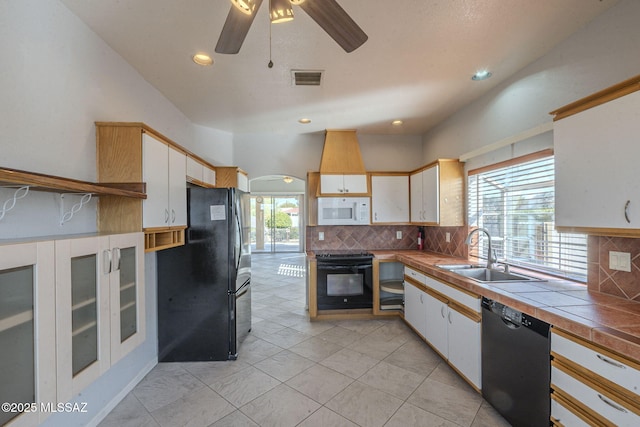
top-left (553, 92), bottom-right (640, 234)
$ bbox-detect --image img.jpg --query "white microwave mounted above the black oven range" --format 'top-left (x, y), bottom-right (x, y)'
top-left (318, 197), bottom-right (369, 225)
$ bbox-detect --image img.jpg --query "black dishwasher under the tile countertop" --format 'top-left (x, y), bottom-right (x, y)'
top-left (482, 297), bottom-right (551, 427)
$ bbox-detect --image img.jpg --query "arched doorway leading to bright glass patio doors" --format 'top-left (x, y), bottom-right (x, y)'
top-left (250, 175), bottom-right (305, 253)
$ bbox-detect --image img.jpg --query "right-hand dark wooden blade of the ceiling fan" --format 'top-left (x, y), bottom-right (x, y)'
top-left (299, 0), bottom-right (369, 52)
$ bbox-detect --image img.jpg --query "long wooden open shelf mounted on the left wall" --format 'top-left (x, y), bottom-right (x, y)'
top-left (0, 167), bottom-right (147, 199)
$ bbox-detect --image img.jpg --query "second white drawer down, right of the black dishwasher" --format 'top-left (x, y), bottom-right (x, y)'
top-left (551, 366), bottom-right (640, 427)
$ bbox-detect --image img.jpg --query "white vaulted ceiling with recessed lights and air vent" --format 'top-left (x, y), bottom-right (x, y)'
top-left (61, 0), bottom-right (617, 135)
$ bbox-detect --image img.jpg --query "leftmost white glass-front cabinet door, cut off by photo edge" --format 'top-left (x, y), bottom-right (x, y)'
top-left (0, 242), bottom-right (56, 425)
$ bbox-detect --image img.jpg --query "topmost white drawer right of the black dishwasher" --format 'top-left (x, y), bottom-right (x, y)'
top-left (551, 330), bottom-right (640, 394)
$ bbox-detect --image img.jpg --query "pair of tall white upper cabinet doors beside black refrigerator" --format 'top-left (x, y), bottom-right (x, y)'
top-left (142, 133), bottom-right (187, 228)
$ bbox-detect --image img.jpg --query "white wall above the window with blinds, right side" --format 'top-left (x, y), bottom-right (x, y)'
top-left (423, 0), bottom-right (640, 171)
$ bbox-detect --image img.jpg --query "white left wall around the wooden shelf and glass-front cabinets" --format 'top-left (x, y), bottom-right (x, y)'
top-left (0, 0), bottom-right (206, 426)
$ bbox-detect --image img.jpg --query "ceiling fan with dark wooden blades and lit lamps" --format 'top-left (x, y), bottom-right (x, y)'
top-left (215, 0), bottom-right (368, 54)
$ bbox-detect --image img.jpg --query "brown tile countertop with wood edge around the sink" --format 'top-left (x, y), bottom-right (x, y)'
top-left (370, 250), bottom-right (640, 361)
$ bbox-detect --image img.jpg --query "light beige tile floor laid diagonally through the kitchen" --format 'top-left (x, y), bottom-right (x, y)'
top-left (100, 254), bottom-right (509, 427)
